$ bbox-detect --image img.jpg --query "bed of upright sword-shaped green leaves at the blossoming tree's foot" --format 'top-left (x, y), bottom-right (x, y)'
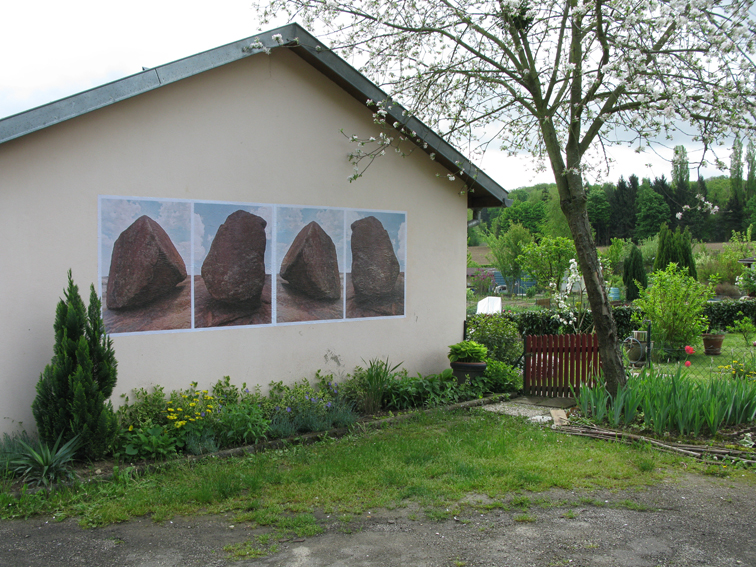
top-left (577, 365), bottom-right (756, 436)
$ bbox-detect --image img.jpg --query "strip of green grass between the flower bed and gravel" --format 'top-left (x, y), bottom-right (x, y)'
top-left (0, 410), bottom-right (744, 528)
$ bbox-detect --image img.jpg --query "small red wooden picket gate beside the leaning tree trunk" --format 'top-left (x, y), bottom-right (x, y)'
top-left (523, 334), bottom-right (601, 398)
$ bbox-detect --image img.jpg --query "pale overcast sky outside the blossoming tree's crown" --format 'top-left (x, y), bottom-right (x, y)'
top-left (0, 0), bottom-right (729, 189)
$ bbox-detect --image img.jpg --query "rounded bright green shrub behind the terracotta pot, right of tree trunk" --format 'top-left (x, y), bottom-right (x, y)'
top-left (635, 264), bottom-right (713, 350)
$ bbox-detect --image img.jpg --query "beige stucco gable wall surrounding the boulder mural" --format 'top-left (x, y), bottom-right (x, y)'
top-left (0, 51), bottom-right (466, 432)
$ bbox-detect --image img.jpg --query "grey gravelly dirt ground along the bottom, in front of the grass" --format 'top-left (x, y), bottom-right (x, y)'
top-left (0, 472), bottom-right (756, 567)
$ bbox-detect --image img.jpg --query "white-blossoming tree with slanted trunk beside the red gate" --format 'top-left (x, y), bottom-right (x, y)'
top-left (261, 0), bottom-right (756, 391)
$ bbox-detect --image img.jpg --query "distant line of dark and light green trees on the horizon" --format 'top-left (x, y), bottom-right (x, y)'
top-left (468, 138), bottom-right (756, 246)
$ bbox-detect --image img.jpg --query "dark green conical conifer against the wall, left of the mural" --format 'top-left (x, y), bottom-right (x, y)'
top-left (32, 270), bottom-right (117, 459)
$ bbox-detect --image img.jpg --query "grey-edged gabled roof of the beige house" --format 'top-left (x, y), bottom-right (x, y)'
top-left (0, 24), bottom-right (511, 208)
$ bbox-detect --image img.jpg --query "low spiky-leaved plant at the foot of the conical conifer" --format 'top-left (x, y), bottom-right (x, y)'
top-left (11, 432), bottom-right (82, 488)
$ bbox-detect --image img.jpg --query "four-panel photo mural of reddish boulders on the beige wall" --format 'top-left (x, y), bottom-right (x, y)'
top-left (99, 196), bottom-right (406, 334)
